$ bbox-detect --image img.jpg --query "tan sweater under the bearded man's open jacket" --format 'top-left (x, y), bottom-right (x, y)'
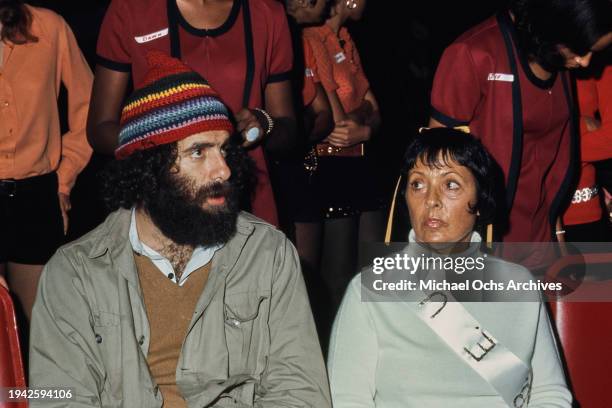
top-left (134, 253), bottom-right (210, 408)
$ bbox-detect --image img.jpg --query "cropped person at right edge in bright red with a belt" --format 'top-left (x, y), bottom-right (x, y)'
top-left (563, 65), bottom-right (612, 242)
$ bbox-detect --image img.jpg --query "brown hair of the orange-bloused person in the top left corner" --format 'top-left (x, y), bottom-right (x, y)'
top-left (0, 0), bottom-right (38, 44)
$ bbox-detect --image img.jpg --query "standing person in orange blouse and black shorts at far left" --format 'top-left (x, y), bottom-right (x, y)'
top-left (0, 0), bottom-right (92, 318)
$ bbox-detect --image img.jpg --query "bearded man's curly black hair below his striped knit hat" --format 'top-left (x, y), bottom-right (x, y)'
top-left (100, 142), bottom-right (256, 211)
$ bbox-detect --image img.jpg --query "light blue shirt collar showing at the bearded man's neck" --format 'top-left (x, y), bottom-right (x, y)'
top-left (130, 208), bottom-right (222, 286)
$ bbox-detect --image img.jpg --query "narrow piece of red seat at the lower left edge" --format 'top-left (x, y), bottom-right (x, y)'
top-left (0, 286), bottom-right (27, 408)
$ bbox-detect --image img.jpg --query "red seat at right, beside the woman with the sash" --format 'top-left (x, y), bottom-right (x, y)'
top-left (551, 254), bottom-right (612, 408)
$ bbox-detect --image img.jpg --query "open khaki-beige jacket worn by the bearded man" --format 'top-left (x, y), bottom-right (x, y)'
top-left (30, 210), bottom-right (331, 408)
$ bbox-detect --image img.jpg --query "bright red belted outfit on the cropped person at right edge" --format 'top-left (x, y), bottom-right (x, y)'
top-left (563, 66), bottom-right (612, 225)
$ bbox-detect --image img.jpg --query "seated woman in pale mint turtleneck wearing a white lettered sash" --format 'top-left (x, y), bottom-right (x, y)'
top-left (328, 129), bottom-right (572, 408)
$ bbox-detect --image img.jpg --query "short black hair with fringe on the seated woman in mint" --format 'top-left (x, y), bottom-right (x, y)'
top-left (401, 128), bottom-right (496, 226)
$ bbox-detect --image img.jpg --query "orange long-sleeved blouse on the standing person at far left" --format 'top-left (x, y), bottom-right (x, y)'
top-left (0, 6), bottom-right (93, 194)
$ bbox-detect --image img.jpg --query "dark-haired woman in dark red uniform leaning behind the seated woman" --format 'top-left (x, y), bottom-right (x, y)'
top-left (430, 0), bottom-right (612, 255)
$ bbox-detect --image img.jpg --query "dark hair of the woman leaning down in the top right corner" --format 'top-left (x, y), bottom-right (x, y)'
top-left (510, 0), bottom-right (612, 72)
